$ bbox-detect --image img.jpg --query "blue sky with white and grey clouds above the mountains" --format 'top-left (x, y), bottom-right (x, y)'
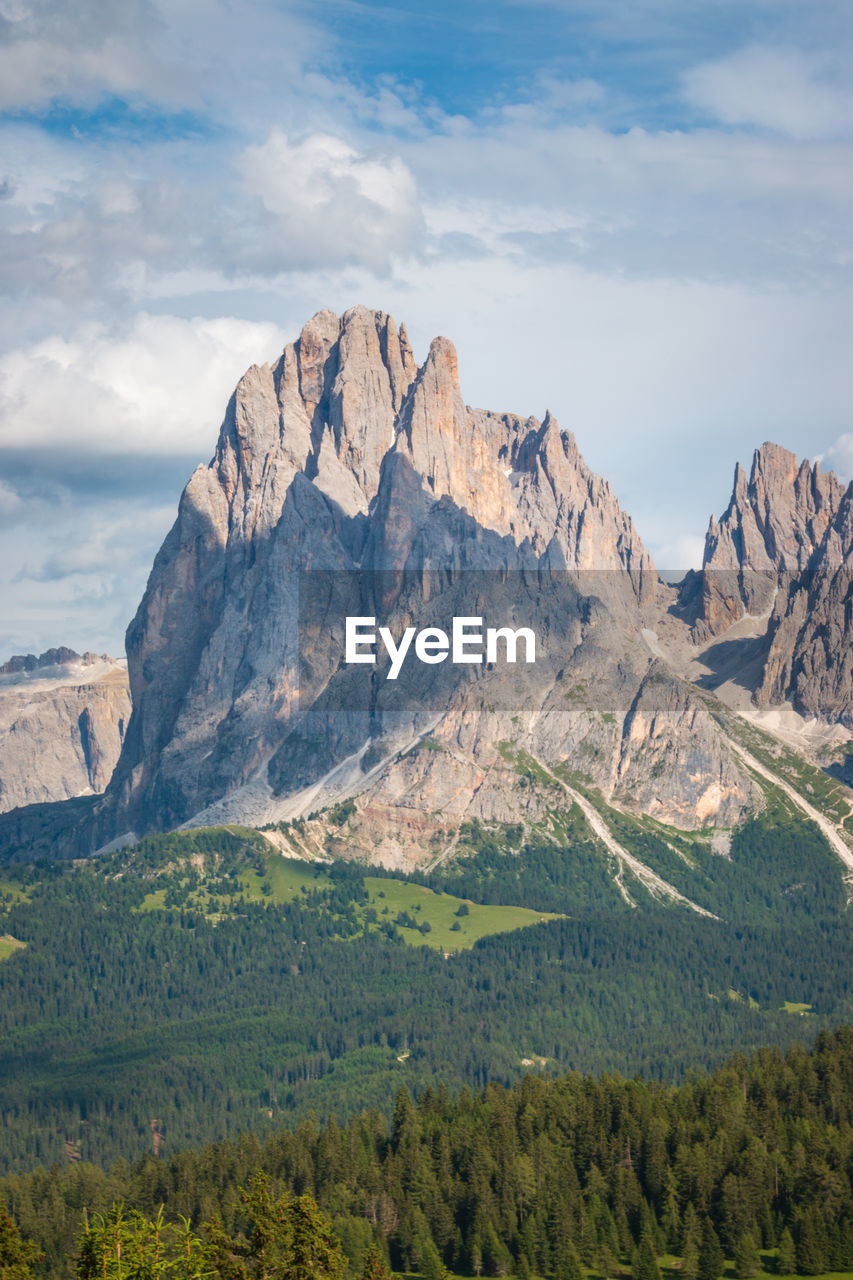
top-left (0, 0), bottom-right (853, 660)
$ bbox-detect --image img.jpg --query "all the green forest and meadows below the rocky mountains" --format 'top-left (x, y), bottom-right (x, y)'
top-left (0, 812), bottom-right (853, 1280)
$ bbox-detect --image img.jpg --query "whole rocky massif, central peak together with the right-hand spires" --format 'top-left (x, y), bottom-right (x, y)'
top-left (0, 307), bottom-right (853, 909)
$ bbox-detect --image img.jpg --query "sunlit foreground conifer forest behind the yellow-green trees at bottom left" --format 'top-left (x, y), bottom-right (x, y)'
top-left (0, 1027), bottom-right (853, 1280)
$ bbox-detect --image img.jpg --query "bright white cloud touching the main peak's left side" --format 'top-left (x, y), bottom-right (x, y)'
top-left (0, 315), bottom-right (282, 458)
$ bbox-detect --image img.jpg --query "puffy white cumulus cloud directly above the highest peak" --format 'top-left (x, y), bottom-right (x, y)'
top-left (236, 129), bottom-right (423, 273)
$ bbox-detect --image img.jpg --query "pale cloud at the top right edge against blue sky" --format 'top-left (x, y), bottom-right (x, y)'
top-left (683, 45), bottom-right (853, 138)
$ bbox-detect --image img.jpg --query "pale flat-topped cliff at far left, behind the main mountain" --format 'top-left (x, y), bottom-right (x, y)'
top-left (0, 649), bottom-right (131, 813)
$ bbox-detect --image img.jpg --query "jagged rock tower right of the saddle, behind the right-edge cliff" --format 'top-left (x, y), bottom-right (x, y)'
top-left (697, 444), bottom-right (844, 639)
